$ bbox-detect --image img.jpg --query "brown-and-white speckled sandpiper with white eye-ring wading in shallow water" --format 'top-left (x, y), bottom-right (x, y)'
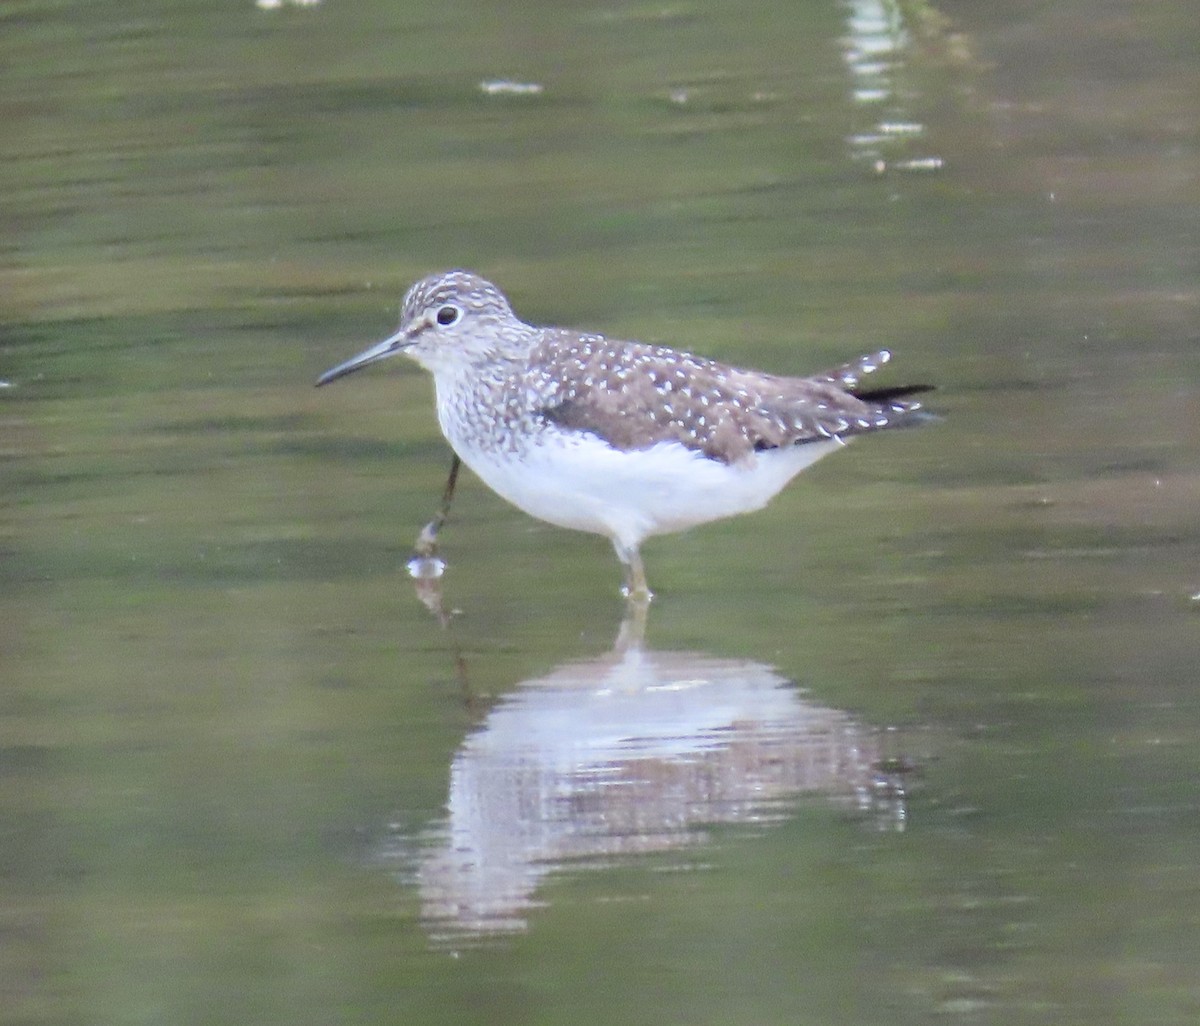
top-left (317, 270), bottom-right (926, 601)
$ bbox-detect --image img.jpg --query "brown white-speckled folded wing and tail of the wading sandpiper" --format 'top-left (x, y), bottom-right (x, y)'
top-left (530, 331), bottom-right (920, 463)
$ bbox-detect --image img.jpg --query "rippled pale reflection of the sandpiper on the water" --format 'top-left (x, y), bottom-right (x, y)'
top-left (389, 580), bottom-right (905, 941)
